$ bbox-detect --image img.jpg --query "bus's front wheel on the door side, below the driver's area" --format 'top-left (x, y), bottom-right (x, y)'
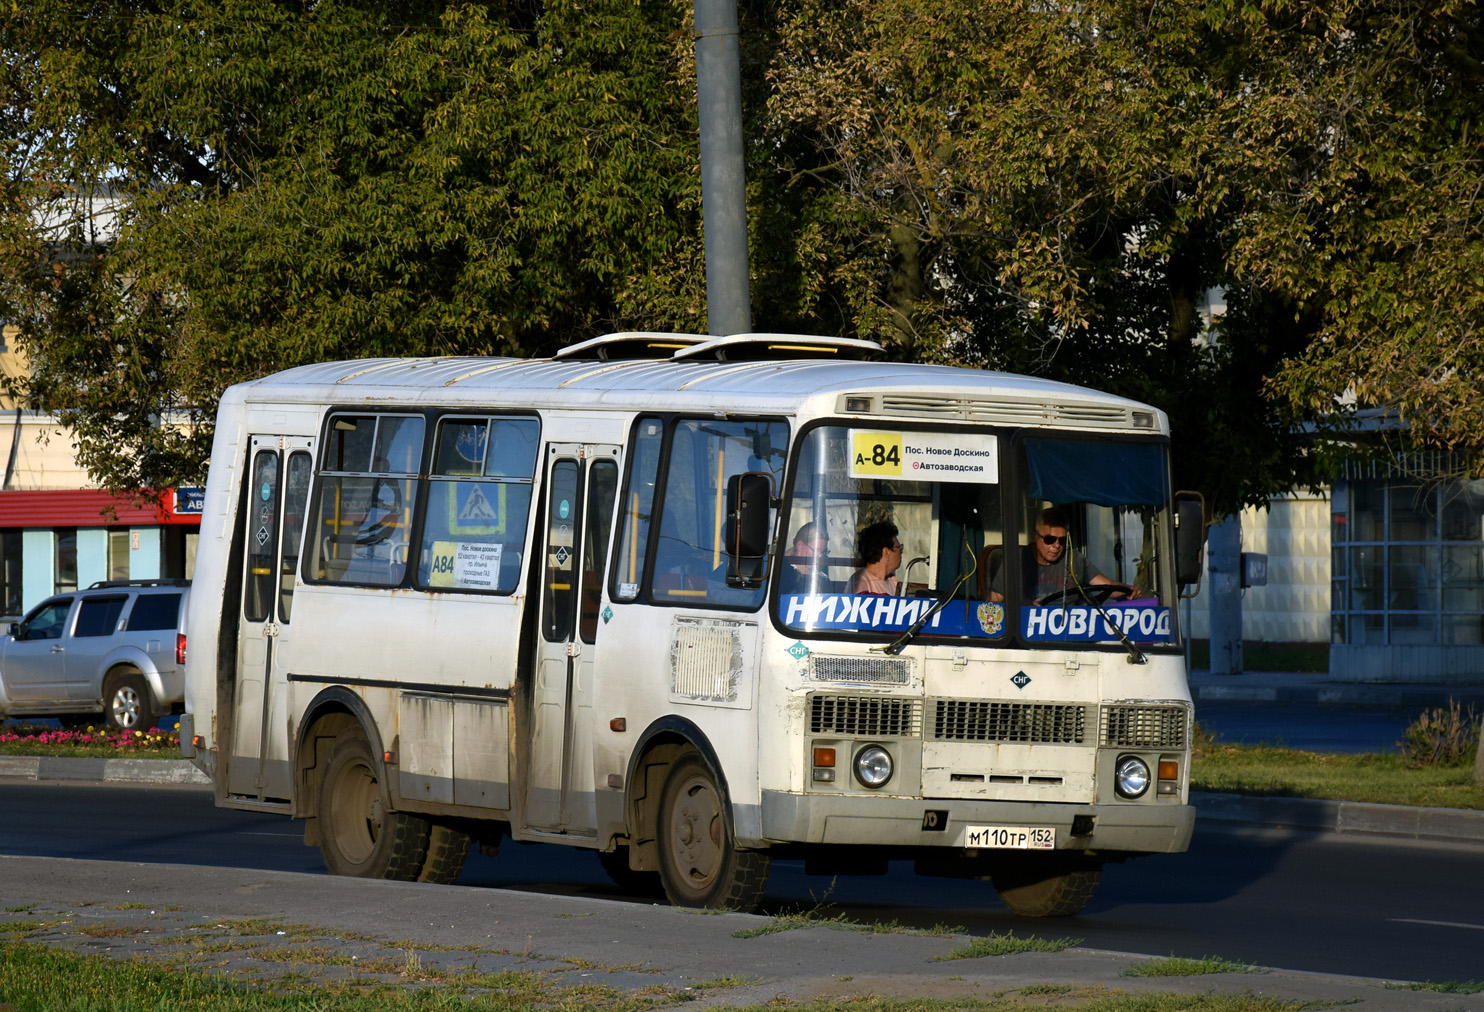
top-left (656, 752), bottom-right (770, 913)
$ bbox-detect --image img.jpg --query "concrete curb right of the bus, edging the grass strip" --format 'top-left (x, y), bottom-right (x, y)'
top-left (1190, 791), bottom-right (1484, 843)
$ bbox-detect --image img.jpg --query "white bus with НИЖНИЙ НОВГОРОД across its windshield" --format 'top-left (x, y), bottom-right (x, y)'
top-left (181, 334), bottom-right (1202, 916)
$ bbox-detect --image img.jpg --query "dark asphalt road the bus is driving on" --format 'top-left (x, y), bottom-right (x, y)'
top-left (0, 782), bottom-right (1484, 981)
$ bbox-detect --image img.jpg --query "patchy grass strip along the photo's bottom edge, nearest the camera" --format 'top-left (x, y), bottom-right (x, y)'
top-left (0, 944), bottom-right (1345, 1012)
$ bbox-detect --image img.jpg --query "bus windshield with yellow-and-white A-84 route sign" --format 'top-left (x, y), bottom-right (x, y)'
top-left (775, 424), bottom-right (1178, 647)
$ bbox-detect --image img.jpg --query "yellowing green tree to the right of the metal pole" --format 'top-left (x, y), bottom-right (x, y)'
top-left (770, 0), bottom-right (1484, 513)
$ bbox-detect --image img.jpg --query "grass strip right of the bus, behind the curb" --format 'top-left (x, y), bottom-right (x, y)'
top-left (1190, 737), bottom-right (1484, 810)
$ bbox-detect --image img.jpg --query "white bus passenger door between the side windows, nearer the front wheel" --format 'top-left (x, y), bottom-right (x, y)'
top-left (525, 444), bottom-right (619, 835)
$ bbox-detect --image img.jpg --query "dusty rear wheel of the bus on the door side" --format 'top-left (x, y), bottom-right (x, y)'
top-left (316, 727), bottom-right (429, 881)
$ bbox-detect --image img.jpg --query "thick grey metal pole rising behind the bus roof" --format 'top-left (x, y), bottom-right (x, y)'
top-left (695, 0), bottom-right (752, 337)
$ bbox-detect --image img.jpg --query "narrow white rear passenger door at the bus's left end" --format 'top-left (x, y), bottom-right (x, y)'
top-left (227, 436), bottom-right (313, 801)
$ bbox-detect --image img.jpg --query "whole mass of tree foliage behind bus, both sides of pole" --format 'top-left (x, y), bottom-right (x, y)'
top-left (0, 0), bottom-right (1484, 513)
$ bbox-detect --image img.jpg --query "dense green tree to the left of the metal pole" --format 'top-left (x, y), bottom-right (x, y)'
top-left (0, 0), bottom-right (699, 488)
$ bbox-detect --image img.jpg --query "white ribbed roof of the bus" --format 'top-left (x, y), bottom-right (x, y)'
top-left (224, 334), bottom-right (1168, 432)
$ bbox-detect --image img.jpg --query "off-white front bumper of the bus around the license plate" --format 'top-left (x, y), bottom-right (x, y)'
top-left (761, 791), bottom-right (1196, 853)
